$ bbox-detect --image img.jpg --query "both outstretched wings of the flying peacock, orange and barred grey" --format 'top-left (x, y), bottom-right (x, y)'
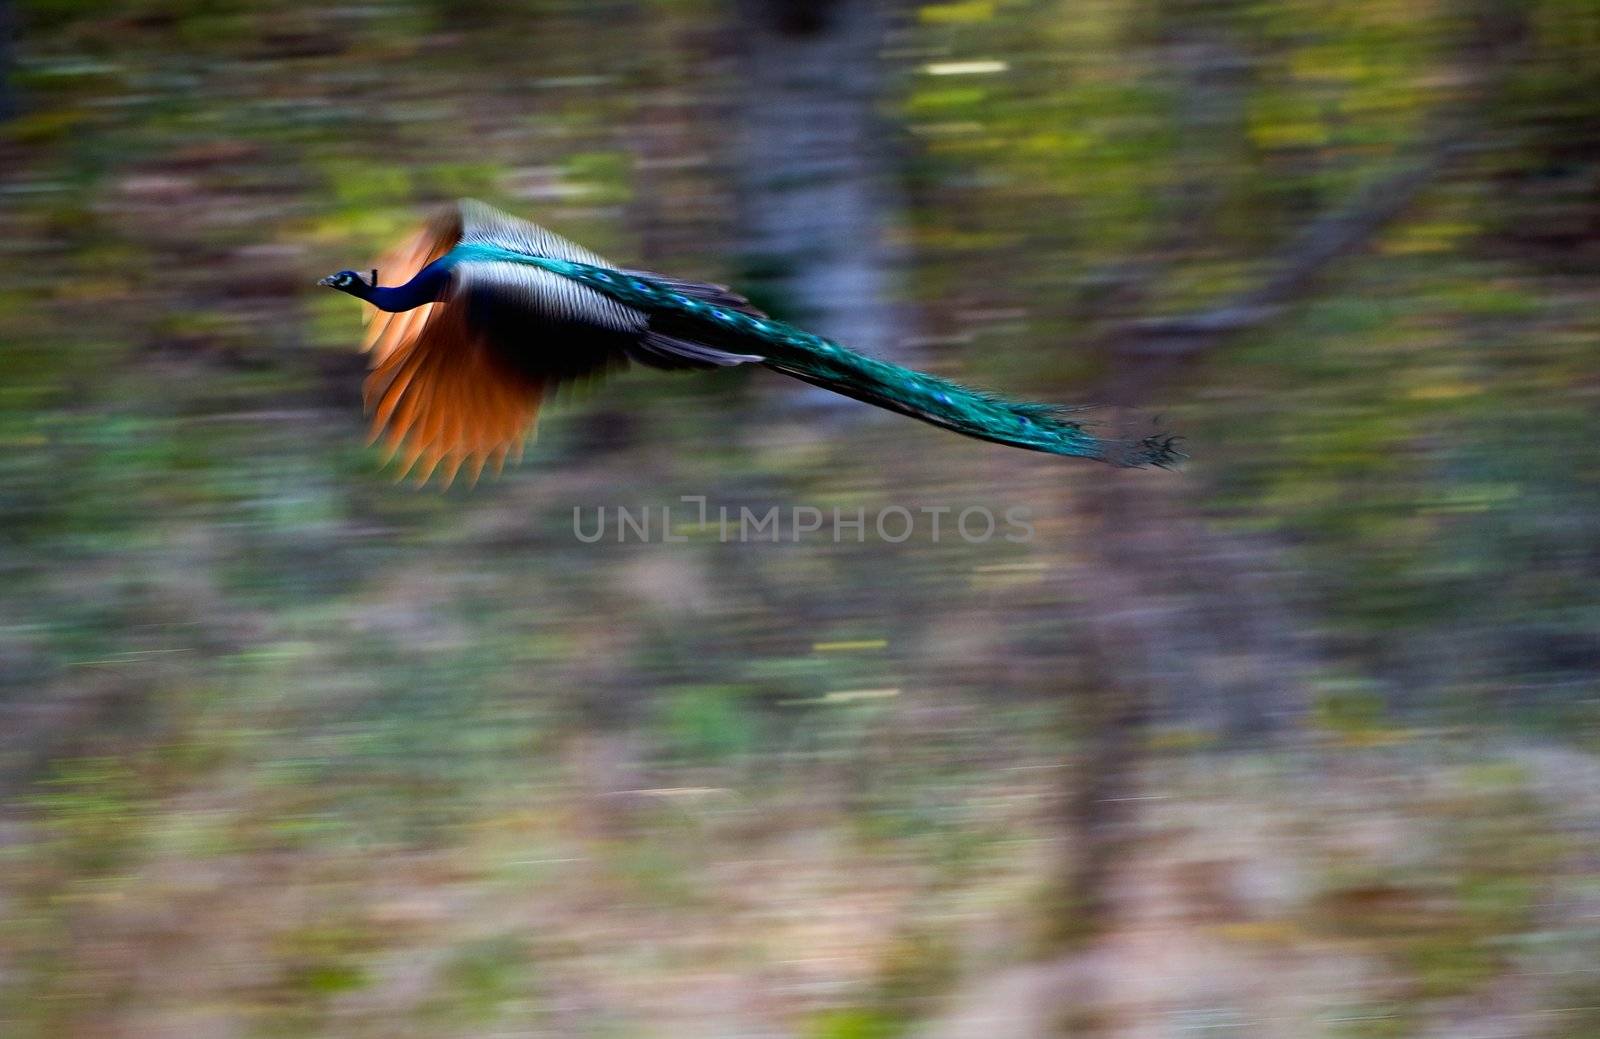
top-left (363, 200), bottom-right (760, 483)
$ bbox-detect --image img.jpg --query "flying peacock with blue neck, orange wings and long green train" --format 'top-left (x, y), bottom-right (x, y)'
top-left (318, 200), bottom-right (1181, 485)
